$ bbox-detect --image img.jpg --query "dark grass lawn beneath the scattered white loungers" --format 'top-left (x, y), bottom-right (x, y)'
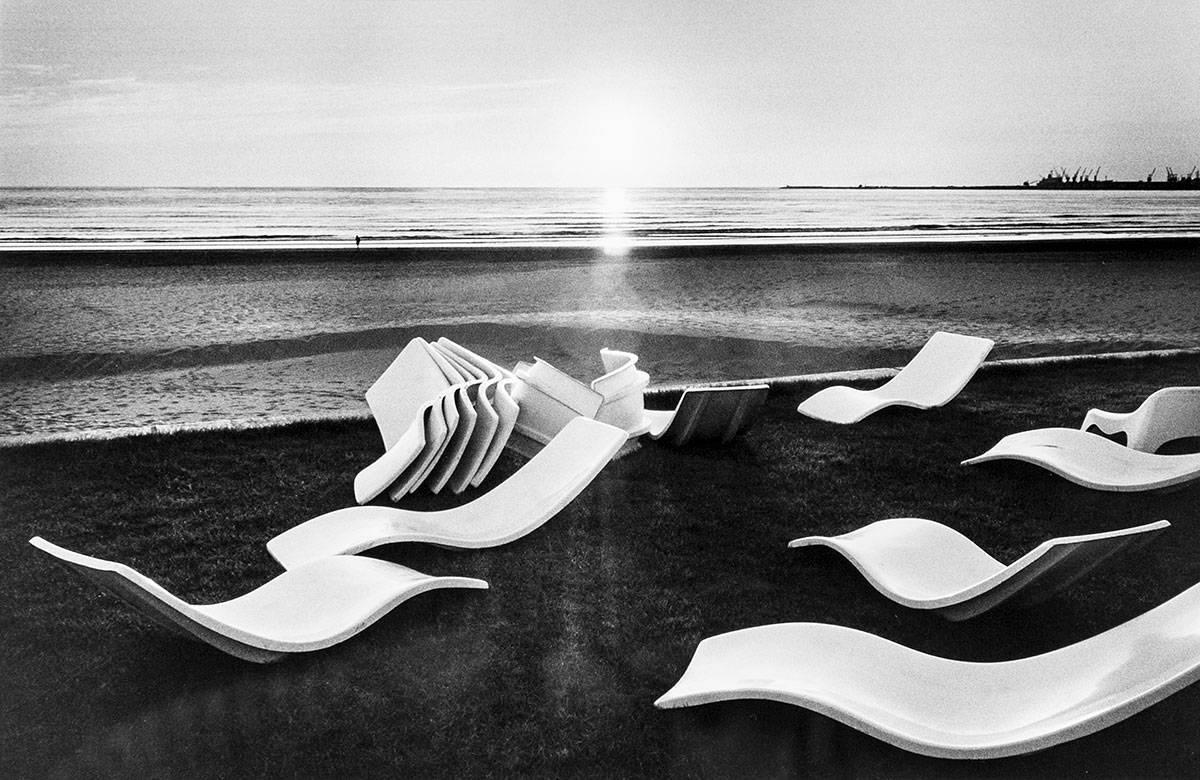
top-left (0, 358), bottom-right (1200, 778)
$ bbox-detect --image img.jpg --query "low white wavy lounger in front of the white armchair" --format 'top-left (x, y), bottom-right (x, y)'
top-left (962, 428), bottom-right (1200, 492)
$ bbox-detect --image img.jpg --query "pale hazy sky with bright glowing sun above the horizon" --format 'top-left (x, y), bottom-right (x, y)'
top-left (0, 0), bottom-right (1200, 186)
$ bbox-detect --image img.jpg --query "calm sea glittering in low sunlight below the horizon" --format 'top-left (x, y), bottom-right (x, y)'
top-left (7, 188), bottom-right (1200, 248)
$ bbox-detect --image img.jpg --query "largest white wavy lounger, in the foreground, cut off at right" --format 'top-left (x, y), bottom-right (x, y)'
top-left (655, 586), bottom-right (1200, 758)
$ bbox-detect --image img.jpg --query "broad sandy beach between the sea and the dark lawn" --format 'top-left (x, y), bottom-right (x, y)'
top-left (0, 240), bottom-right (1200, 437)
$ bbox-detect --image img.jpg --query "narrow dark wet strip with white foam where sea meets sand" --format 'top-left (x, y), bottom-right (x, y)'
top-left (0, 234), bottom-right (1200, 268)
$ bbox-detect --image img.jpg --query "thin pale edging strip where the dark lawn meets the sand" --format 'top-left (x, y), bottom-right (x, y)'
top-left (0, 348), bottom-right (1200, 450)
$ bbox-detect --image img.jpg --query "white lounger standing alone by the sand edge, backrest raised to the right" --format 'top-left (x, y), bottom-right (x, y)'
top-left (797, 331), bottom-right (995, 424)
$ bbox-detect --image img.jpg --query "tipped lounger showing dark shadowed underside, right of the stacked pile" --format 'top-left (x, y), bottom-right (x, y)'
top-left (646, 384), bottom-right (769, 446)
